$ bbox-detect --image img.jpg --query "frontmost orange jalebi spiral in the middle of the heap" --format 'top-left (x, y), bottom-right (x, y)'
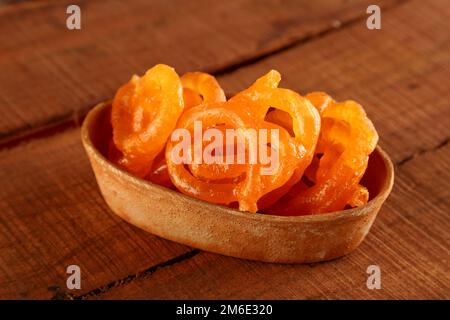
top-left (166, 96), bottom-right (295, 212)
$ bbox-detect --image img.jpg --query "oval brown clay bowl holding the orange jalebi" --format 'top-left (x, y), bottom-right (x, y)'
top-left (81, 102), bottom-right (394, 263)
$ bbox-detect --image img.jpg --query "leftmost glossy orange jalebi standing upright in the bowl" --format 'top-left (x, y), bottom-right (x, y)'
top-left (111, 64), bottom-right (184, 177)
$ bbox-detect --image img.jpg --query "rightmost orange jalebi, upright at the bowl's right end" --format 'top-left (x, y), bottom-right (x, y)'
top-left (267, 92), bottom-right (378, 215)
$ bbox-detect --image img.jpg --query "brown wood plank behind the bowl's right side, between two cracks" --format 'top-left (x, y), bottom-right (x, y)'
top-left (220, 0), bottom-right (450, 161)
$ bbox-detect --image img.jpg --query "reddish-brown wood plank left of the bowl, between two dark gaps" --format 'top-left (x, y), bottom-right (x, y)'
top-left (0, 129), bottom-right (191, 299)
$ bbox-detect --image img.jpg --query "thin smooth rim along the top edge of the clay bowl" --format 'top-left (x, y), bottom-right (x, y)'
top-left (81, 100), bottom-right (394, 225)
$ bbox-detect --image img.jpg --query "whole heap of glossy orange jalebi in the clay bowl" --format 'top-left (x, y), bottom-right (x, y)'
top-left (108, 65), bottom-right (378, 215)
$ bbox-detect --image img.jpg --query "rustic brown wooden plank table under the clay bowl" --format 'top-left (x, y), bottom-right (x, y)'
top-left (0, 0), bottom-right (450, 299)
